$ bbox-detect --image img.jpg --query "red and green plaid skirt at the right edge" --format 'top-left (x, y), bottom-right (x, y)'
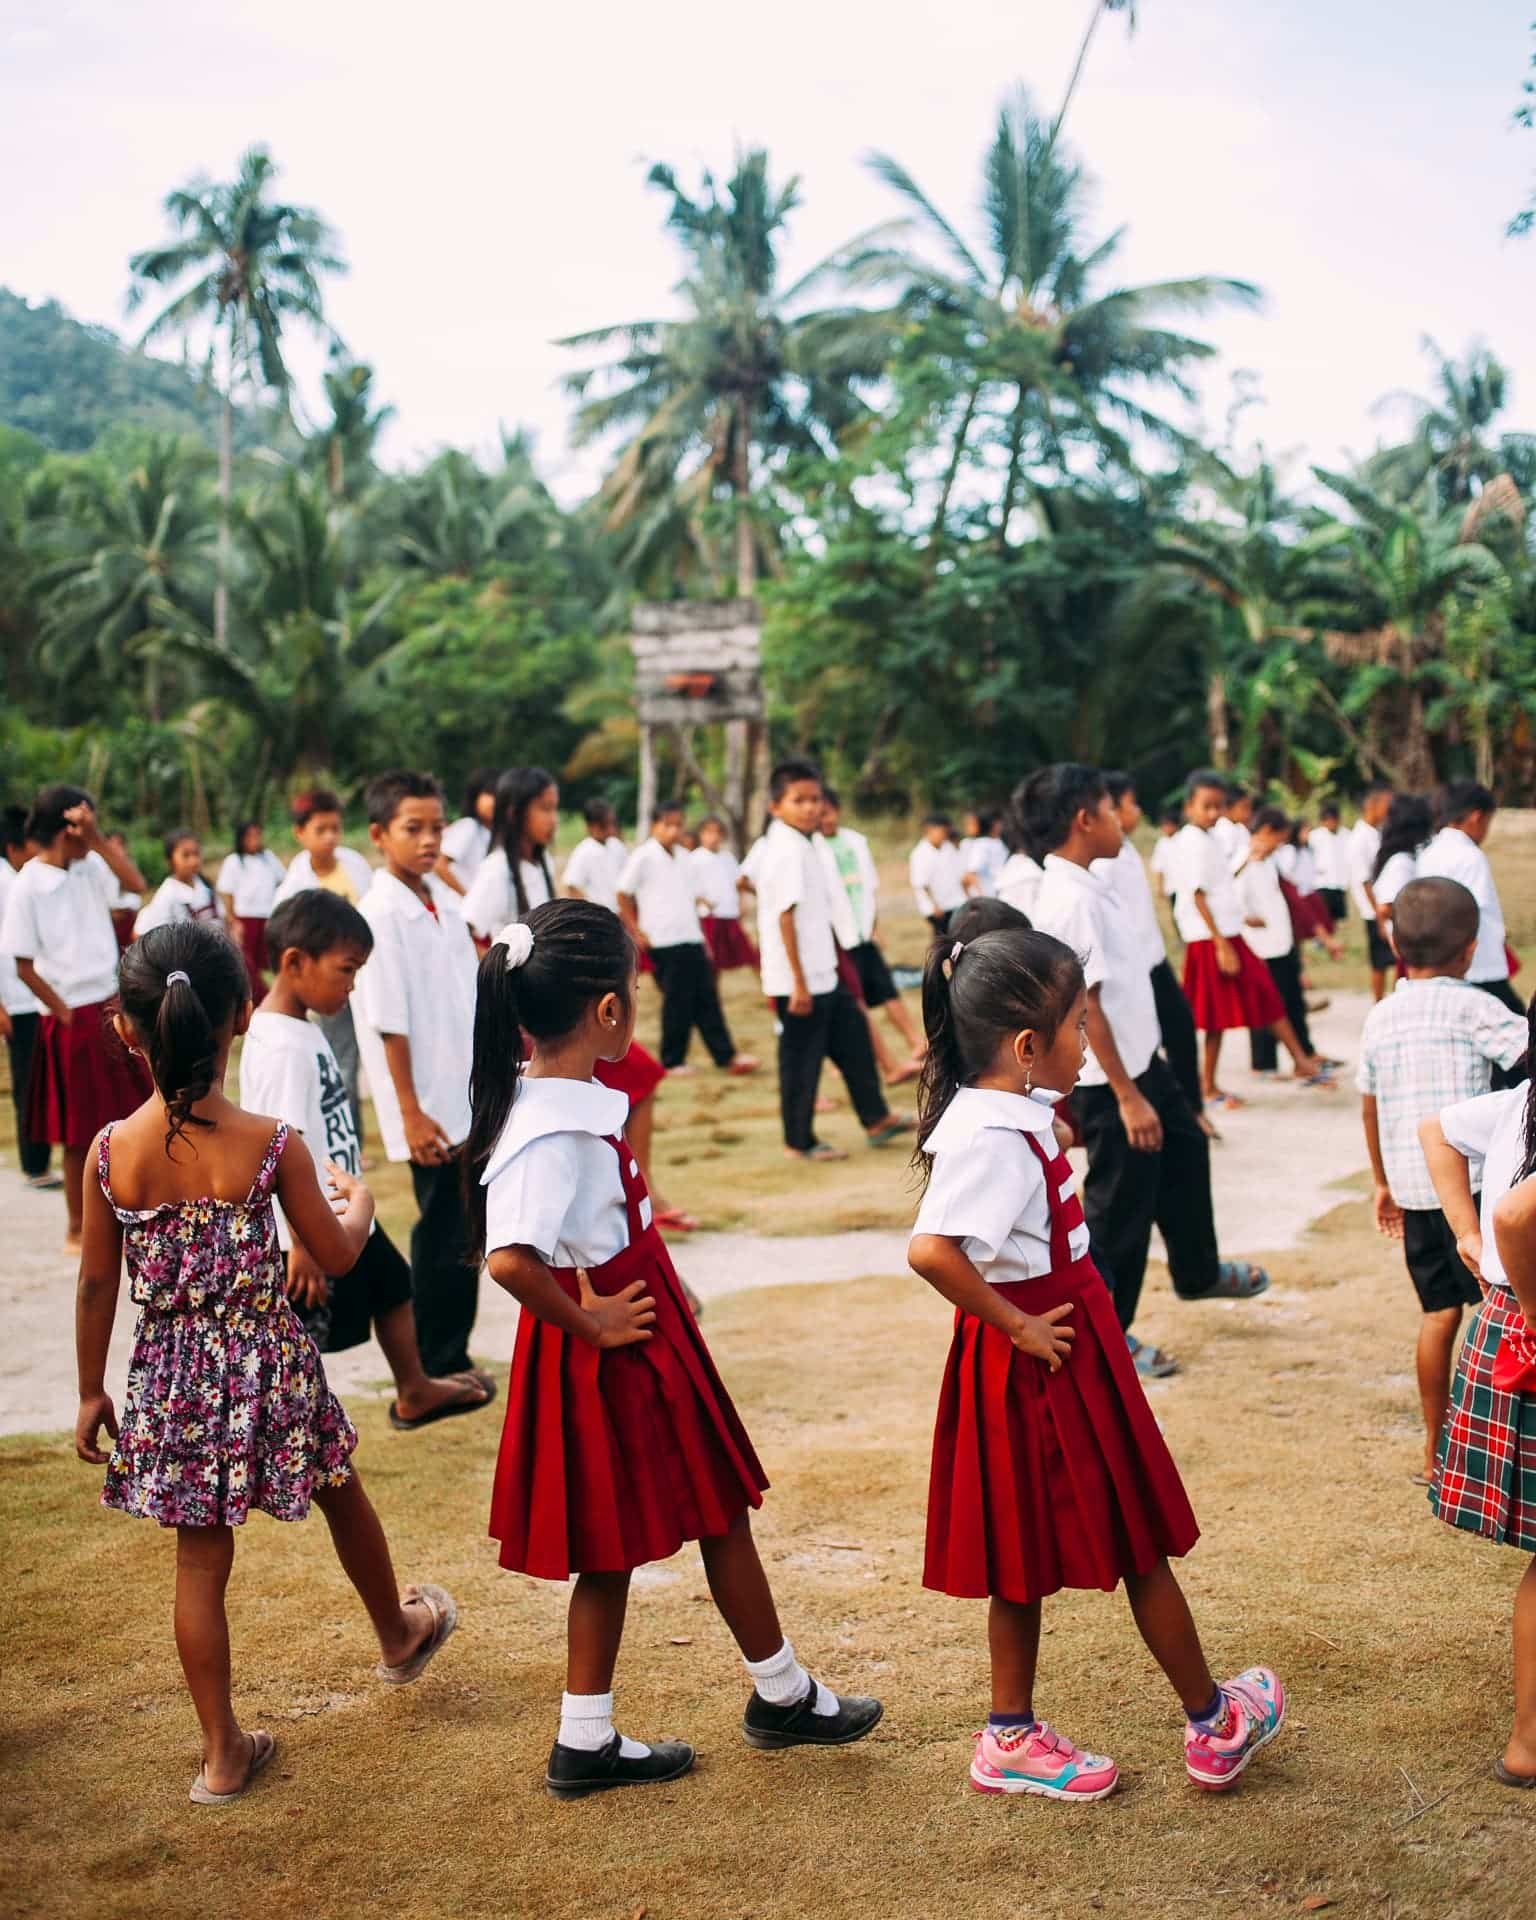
top-left (1428, 1288), bottom-right (1536, 1553)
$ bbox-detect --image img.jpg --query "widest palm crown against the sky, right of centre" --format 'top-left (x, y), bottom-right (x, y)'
top-left (845, 90), bottom-right (1260, 551)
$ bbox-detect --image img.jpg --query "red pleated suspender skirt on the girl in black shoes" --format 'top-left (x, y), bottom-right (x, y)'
top-left (490, 1139), bottom-right (768, 1580)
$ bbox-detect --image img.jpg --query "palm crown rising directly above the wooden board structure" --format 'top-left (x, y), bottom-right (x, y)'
top-left (559, 152), bottom-right (889, 597)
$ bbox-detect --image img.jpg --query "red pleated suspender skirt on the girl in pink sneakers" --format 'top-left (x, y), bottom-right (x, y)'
top-left (924, 1133), bottom-right (1200, 1605)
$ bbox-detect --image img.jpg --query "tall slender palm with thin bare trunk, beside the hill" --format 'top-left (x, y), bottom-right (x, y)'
top-left (127, 146), bottom-right (346, 645)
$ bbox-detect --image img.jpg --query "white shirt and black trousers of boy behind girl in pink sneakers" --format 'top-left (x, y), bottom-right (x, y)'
top-left (1029, 852), bottom-right (1221, 1329)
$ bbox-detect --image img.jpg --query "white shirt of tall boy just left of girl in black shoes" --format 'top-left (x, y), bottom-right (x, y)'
top-left (351, 868), bottom-right (476, 1160)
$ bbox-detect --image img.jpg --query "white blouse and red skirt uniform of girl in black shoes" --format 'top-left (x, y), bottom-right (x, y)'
top-left (482, 1082), bottom-right (768, 1580)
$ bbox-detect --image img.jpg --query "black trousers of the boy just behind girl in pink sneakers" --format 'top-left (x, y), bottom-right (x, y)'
top-left (1073, 1056), bottom-right (1221, 1331)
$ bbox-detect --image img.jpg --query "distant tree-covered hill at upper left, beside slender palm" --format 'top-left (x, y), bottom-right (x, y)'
top-left (0, 286), bottom-right (272, 453)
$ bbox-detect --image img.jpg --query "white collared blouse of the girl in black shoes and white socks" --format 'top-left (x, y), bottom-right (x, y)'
top-left (480, 1073), bottom-right (651, 1267)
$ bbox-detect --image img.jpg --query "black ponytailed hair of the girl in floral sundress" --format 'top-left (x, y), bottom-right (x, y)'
top-left (117, 920), bottom-right (252, 1154)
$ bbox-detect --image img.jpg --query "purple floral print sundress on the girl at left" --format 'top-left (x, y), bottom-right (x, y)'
top-left (96, 1125), bottom-right (357, 1526)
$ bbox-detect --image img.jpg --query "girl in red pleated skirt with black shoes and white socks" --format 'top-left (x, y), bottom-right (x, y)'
top-left (467, 900), bottom-right (883, 1799)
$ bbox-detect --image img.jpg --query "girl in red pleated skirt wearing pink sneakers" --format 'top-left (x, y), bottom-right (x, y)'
top-left (908, 927), bottom-right (1284, 1801)
